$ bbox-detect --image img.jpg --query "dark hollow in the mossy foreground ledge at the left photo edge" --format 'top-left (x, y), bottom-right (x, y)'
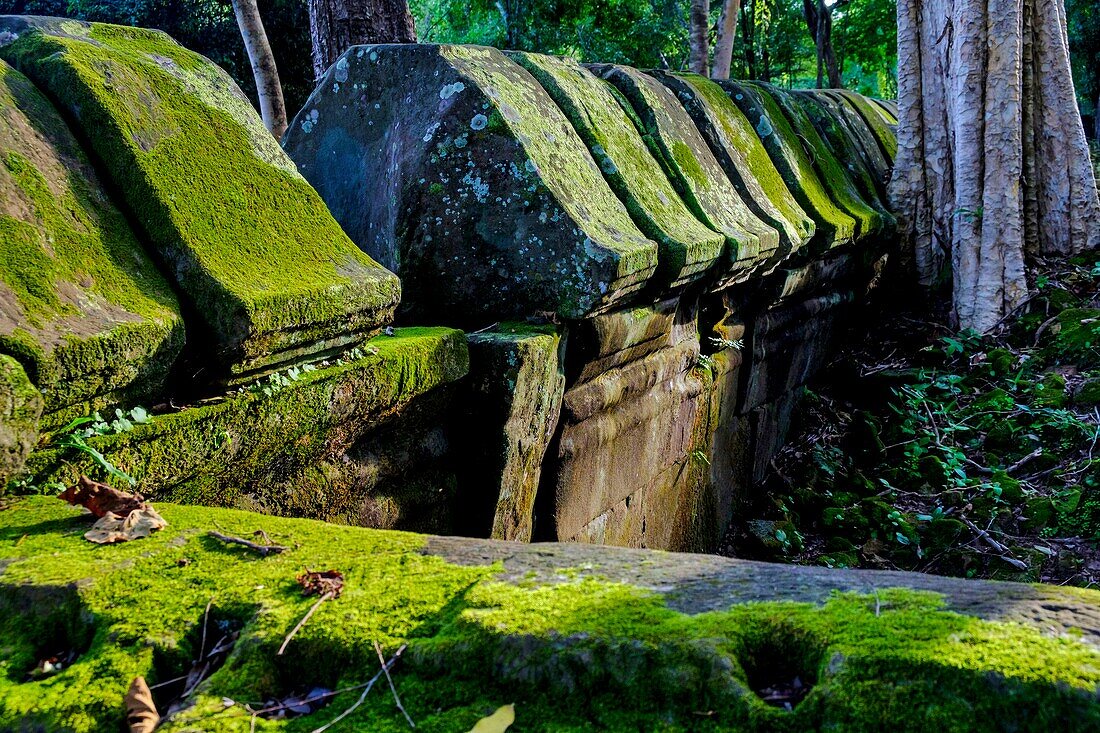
top-left (0, 584), bottom-right (96, 682)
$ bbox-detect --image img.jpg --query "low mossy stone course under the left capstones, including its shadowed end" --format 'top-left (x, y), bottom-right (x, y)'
top-left (26, 328), bottom-right (469, 529)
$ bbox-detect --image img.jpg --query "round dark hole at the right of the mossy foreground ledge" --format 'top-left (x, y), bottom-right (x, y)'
top-left (740, 626), bottom-right (824, 710)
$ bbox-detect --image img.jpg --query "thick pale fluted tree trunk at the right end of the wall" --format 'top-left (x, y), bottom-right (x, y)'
top-left (890, 0), bottom-right (1100, 331)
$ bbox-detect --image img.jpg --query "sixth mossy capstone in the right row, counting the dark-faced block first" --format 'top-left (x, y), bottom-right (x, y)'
top-left (750, 83), bottom-right (895, 241)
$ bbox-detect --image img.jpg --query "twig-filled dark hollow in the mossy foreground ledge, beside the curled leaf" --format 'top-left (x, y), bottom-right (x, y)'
top-left (150, 604), bottom-right (254, 716)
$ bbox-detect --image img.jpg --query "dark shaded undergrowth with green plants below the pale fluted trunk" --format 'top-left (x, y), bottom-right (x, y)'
top-left (724, 248), bottom-right (1100, 587)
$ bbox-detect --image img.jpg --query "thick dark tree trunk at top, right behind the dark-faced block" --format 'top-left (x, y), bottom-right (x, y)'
top-left (309, 0), bottom-right (416, 79)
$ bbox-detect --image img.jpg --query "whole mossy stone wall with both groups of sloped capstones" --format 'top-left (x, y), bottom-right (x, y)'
top-left (0, 17), bottom-right (897, 549)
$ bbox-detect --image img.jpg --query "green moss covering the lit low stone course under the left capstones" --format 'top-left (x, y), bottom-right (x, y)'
top-left (26, 328), bottom-right (469, 518)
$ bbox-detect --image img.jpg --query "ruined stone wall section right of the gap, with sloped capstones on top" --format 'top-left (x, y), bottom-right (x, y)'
top-left (284, 45), bottom-right (894, 550)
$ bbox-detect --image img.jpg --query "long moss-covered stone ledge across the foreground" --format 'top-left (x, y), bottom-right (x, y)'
top-left (0, 497), bottom-right (1100, 731)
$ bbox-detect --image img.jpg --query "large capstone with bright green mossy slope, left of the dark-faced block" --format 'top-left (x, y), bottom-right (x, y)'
top-left (0, 17), bottom-right (400, 373)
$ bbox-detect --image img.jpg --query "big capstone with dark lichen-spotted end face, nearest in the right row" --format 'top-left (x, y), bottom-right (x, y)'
top-left (285, 44), bottom-right (658, 325)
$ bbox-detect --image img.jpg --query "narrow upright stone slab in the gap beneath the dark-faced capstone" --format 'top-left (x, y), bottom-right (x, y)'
top-left (455, 324), bottom-right (565, 541)
